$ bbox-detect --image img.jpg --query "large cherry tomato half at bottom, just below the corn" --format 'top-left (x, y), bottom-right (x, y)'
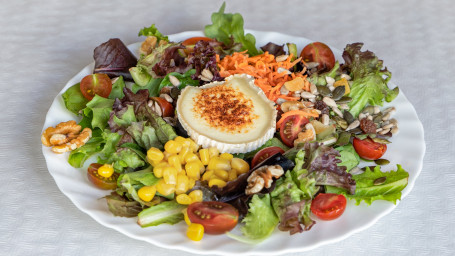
top-left (187, 201), bottom-right (239, 235)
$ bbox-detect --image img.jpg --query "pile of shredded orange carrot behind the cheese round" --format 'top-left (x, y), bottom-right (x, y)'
top-left (216, 51), bottom-right (310, 102)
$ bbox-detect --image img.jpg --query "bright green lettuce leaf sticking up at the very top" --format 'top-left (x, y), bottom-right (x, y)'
top-left (204, 3), bottom-right (261, 56)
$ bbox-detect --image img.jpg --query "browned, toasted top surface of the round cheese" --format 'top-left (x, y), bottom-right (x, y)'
top-left (193, 84), bottom-right (258, 133)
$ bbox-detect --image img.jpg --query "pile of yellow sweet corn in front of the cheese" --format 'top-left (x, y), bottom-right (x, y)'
top-left (143, 136), bottom-right (250, 205)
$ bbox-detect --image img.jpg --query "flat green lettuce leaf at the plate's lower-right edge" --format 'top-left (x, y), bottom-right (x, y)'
top-left (326, 164), bottom-right (409, 205)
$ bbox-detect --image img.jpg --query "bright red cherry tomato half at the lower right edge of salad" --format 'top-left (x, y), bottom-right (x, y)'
top-left (311, 193), bottom-right (346, 220)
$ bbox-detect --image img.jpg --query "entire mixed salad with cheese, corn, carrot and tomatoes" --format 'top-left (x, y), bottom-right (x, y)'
top-left (41, 4), bottom-right (409, 243)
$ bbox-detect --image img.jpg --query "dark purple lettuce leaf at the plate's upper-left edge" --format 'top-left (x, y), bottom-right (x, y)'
top-left (93, 38), bottom-right (137, 81)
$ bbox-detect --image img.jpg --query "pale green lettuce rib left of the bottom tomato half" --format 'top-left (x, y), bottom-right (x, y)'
top-left (137, 201), bottom-right (186, 228)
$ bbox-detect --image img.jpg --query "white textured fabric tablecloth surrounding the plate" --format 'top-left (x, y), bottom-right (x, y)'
top-left (0, 0), bottom-right (455, 255)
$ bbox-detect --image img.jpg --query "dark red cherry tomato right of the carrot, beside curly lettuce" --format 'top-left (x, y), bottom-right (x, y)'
top-left (300, 42), bottom-right (335, 71)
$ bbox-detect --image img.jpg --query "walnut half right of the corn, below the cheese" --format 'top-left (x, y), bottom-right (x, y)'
top-left (245, 165), bottom-right (284, 195)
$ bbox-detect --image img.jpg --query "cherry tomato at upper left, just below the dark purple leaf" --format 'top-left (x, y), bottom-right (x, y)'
top-left (80, 73), bottom-right (112, 100)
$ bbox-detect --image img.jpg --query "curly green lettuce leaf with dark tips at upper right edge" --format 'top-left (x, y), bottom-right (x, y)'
top-left (343, 43), bottom-right (399, 117)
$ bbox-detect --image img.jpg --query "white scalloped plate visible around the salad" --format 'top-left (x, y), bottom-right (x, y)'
top-left (43, 31), bottom-right (425, 255)
